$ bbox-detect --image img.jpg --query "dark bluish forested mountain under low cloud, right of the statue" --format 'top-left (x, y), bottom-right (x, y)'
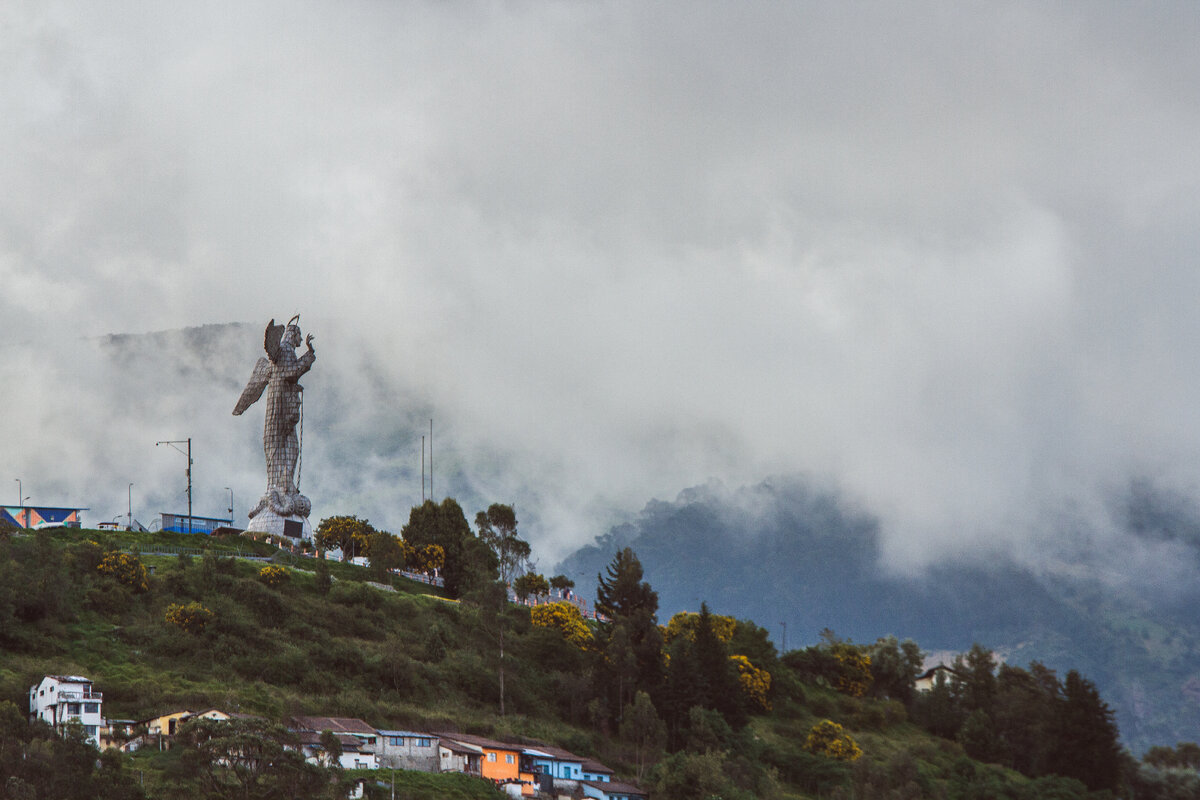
top-left (559, 479), bottom-right (1200, 751)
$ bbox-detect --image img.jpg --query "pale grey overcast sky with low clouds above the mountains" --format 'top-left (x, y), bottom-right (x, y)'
top-left (0, 0), bottom-right (1200, 564)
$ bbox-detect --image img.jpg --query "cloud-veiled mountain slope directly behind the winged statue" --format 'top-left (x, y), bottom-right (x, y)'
top-left (69, 318), bottom-right (510, 531)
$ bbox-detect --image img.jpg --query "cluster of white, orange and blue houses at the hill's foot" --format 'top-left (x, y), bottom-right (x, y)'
top-left (29, 675), bottom-right (649, 800)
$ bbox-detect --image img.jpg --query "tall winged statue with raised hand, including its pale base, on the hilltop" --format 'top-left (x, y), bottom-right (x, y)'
top-left (233, 314), bottom-right (317, 539)
